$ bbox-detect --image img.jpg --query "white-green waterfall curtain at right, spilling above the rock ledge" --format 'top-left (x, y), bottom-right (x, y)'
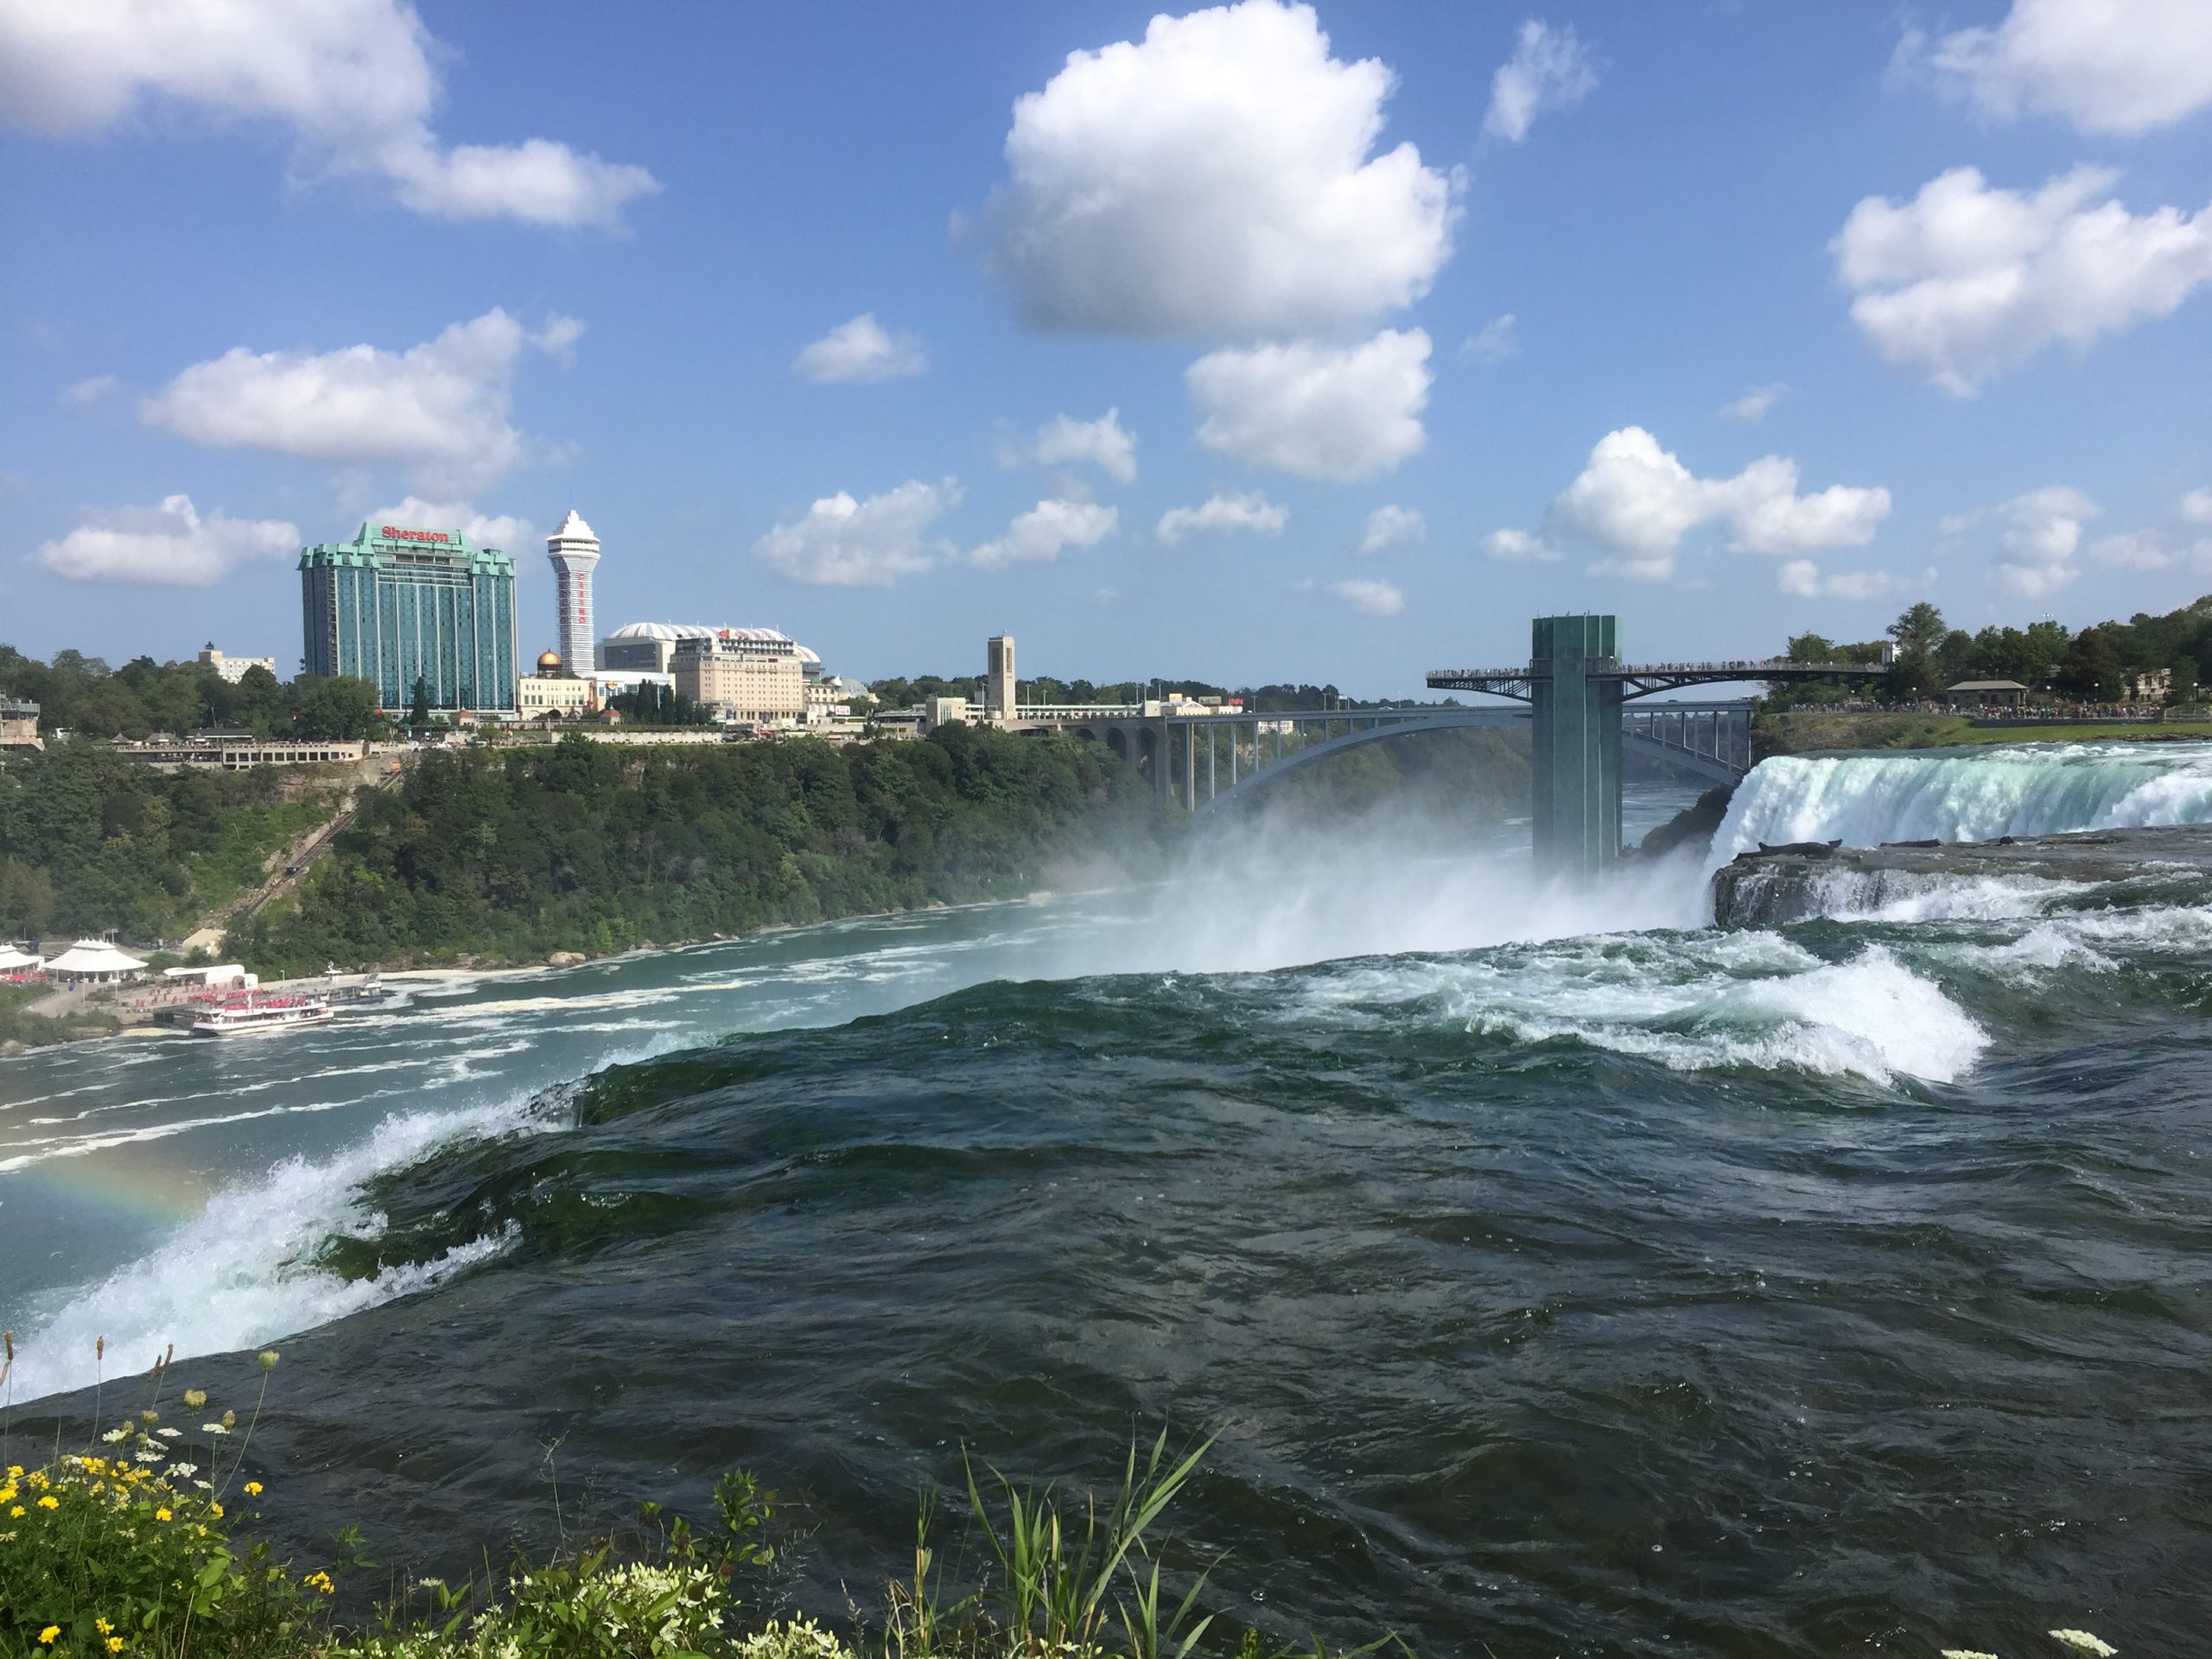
top-left (1706, 741), bottom-right (2212, 869)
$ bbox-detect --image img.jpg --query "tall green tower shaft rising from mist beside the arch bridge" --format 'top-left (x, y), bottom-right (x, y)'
top-left (1529, 617), bottom-right (1621, 876)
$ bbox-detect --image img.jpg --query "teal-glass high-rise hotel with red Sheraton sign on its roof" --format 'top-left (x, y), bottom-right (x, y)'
top-left (299, 524), bottom-right (518, 715)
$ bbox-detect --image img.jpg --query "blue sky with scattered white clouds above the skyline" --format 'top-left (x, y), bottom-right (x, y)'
top-left (0, 0), bottom-right (2212, 695)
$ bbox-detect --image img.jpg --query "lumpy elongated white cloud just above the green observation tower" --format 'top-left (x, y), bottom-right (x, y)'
top-left (1546, 427), bottom-right (1889, 582)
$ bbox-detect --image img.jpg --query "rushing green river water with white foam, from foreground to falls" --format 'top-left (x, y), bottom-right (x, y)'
top-left (0, 746), bottom-right (2212, 1659)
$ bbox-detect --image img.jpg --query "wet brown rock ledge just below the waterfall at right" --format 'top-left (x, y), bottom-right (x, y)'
top-left (1712, 825), bottom-right (2212, 927)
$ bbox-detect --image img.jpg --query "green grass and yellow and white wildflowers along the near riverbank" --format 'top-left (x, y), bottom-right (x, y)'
top-left (0, 1336), bottom-right (1411, 1659)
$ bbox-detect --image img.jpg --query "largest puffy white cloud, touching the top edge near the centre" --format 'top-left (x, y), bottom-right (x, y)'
top-left (978, 0), bottom-right (1455, 336)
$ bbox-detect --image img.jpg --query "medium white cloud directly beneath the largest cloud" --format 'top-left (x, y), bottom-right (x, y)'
top-left (1184, 327), bottom-right (1433, 482)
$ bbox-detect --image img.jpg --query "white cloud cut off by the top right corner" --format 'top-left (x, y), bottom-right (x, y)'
top-left (1897, 0), bottom-right (2212, 137)
